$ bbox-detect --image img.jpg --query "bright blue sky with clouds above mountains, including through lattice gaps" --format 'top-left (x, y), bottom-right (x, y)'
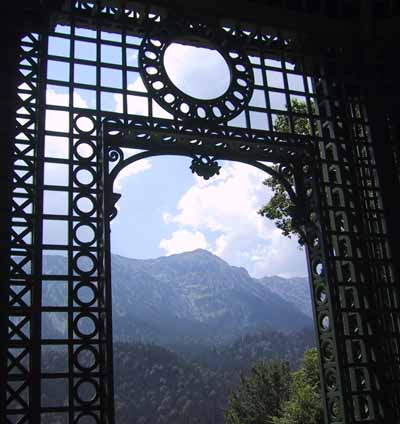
top-left (45, 26), bottom-right (306, 277)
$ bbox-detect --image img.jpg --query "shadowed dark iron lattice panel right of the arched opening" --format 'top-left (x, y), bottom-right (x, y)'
top-left (311, 74), bottom-right (399, 422)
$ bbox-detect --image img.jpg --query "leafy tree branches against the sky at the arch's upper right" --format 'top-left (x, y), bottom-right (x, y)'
top-left (258, 99), bottom-right (314, 245)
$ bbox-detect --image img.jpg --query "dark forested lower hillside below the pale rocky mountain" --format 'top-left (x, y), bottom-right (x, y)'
top-left (42, 329), bottom-right (314, 424)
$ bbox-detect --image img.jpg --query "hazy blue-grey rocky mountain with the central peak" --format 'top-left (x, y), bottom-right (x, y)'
top-left (43, 249), bottom-right (311, 345)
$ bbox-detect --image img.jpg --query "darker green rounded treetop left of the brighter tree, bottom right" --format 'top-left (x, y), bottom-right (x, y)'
top-left (225, 360), bottom-right (291, 424)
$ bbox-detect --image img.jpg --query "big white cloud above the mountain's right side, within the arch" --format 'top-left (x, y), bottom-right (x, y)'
top-left (160, 163), bottom-right (305, 277)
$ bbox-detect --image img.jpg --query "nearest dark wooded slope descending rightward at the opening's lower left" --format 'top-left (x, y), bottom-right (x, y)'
top-left (114, 343), bottom-right (228, 424)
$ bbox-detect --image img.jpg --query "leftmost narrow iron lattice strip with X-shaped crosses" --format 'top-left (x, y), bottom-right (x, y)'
top-left (4, 34), bottom-right (41, 422)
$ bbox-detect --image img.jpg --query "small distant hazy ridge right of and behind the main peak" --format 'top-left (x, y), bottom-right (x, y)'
top-left (257, 275), bottom-right (312, 318)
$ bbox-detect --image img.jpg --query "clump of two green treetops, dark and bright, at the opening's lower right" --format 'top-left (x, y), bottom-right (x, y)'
top-left (225, 349), bottom-right (323, 424)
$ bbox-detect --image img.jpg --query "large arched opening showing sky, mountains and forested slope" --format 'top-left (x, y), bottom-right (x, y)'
top-left (110, 149), bottom-right (314, 424)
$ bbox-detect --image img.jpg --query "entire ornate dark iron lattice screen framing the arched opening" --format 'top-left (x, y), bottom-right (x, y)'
top-left (0, 1), bottom-right (400, 423)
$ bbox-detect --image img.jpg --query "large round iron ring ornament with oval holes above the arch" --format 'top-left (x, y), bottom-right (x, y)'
top-left (139, 25), bottom-right (254, 123)
